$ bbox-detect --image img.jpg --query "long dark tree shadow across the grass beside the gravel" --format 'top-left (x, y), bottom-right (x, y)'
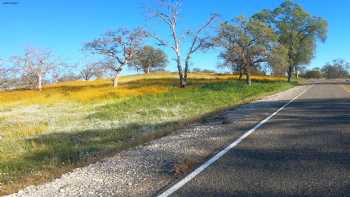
top-left (24, 122), bottom-right (179, 165)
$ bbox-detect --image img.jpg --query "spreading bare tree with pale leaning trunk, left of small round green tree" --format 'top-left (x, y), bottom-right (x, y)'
top-left (85, 28), bottom-right (147, 87)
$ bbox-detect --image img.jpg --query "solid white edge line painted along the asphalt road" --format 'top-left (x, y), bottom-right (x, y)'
top-left (158, 86), bottom-right (312, 197)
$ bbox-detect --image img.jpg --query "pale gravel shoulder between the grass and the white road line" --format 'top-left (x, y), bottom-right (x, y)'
top-left (10, 86), bottom-right (307, 197)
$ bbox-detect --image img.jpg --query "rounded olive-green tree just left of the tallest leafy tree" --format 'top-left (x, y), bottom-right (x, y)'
top-left (214, 16), bottom-right (283, 85)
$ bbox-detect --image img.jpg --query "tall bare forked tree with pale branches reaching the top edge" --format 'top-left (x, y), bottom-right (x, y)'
top-left (146, 0), bottom-right (218, 87)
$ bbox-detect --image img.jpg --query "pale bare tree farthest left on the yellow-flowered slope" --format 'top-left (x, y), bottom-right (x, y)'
top-left (13, 48), bottom-right (57, 91)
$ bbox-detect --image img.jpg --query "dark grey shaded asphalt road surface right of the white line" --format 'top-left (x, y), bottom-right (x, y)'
top-left (167, 81), bottom-right (350, 196)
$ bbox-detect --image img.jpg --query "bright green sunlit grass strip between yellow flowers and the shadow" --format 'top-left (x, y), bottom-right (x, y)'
top-left (90, 81), bottom-right (290, 123)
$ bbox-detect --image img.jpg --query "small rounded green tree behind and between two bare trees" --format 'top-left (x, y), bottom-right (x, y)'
top-left (133, 45), bottom-right (168, 74)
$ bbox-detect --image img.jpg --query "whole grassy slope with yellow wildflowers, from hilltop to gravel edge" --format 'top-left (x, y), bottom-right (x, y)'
top-left (0, 73), bottom-right (292, 194)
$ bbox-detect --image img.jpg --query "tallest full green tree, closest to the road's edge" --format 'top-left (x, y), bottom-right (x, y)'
top-left (254, 0), bottom-right (328, 81)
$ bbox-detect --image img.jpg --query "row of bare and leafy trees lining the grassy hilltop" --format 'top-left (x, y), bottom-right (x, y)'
top-left (0, 0), bottom-right (328, 90)
